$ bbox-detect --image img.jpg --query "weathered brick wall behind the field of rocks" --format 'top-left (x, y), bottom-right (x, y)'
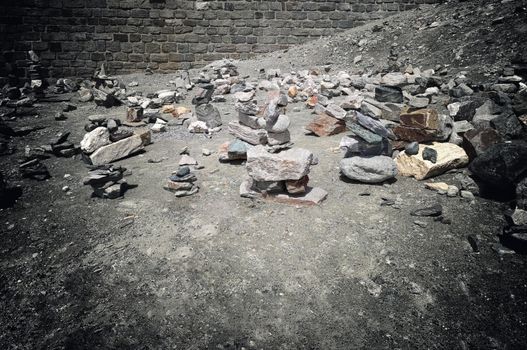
top-left (0, 0), bottom-right (441, 77)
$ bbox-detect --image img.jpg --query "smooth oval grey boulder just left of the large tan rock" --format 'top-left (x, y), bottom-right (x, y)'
top-left (340, 156), bottom-right (397, 183)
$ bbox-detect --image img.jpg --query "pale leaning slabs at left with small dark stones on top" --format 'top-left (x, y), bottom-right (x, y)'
top-left (80, 115), bottom-right (151, 165)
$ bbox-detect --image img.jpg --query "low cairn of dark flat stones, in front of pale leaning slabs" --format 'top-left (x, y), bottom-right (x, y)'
top-left (83, 164), bottom-right (129, 199)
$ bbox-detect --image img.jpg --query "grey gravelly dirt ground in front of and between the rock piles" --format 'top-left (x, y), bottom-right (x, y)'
top-left (0, 0), bottom-right (527, 349)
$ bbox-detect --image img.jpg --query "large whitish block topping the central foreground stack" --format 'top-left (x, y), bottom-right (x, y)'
top-left (246, 146), bottom-right (313, 181)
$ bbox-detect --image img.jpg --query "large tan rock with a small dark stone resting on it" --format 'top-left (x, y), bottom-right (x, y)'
top-left (395, 142), bottom-right (468, 180)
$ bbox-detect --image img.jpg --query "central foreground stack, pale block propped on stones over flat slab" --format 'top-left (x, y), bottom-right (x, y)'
top-left (240, 145), bottom-right (327, 205)
